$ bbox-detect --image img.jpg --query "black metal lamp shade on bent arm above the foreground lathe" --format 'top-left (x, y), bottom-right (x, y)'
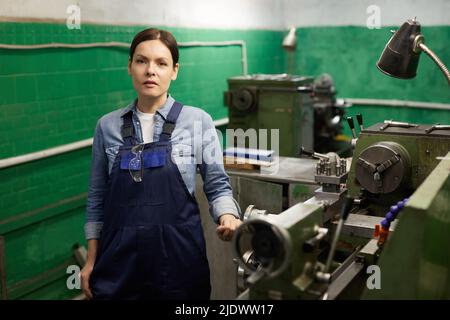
top-left (377, 20), bottom-right (420, 79)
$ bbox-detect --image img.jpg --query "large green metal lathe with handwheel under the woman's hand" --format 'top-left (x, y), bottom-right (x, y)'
top-left (233, 116), bottom-right (450, 300)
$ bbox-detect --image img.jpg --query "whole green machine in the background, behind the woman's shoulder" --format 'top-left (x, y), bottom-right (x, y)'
top-left (225, 74), bottom-right (350, 157)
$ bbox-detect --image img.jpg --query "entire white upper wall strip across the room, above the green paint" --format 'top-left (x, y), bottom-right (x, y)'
top-left (0, 0), bottom-right (450, 30)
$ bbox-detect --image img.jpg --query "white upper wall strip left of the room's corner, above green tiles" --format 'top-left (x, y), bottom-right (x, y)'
top-left (0, 0), bottom-right (283, 29)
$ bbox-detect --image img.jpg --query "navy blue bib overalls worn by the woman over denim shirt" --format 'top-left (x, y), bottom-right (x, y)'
top-left (90, 102), bottom-right (211, 299)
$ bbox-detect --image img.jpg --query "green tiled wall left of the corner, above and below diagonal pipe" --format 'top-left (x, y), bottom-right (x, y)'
top-left (0, 23), bottom-right (285, 298)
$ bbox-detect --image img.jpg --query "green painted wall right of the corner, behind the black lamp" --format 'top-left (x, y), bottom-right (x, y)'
top-left (287, 26), bottom-right (450, 135)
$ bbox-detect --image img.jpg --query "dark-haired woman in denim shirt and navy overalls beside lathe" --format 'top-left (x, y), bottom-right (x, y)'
top-left (81, 28), bottom-right (241, 299)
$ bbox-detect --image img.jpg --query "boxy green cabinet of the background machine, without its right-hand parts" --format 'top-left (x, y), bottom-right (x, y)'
top-left (225, 74), bottom-right (314, 157)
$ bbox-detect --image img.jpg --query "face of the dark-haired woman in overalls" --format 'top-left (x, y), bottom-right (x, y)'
top-left (128, 40), bottom-right (178, 99)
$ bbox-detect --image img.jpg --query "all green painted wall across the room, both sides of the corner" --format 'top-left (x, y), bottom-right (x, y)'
top-left (0, 23), bottom-right (450, 299)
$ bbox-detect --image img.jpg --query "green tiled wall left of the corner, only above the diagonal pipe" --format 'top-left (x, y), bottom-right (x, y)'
top-left (0, 23), bottom-right (284, 157)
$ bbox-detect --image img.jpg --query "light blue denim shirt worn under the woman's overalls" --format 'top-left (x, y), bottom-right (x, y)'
top-left (84, 95), bottom-right (241, 240)
